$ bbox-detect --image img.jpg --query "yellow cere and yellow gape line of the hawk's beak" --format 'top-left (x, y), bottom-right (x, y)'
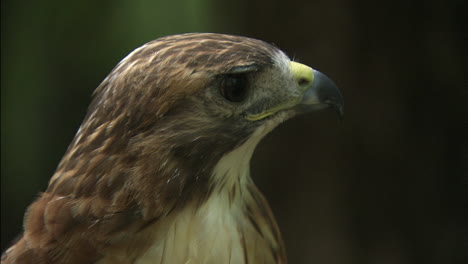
top-left (246, 61), bottom-right (314, 121)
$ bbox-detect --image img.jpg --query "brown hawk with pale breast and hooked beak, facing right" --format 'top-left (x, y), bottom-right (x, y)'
top-left (2, 33), bottom-right (343, 264)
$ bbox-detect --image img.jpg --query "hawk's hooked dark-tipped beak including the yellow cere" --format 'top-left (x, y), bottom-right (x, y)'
top-left (290, 62), bottom-right (344, 119)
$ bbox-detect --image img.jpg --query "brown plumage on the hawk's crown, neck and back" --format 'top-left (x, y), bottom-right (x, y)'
top-left (2, 34), bottom-right (286, 263)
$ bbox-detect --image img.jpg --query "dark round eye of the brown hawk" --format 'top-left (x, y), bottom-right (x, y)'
top-left (220, 74), bottom-right (247, 103)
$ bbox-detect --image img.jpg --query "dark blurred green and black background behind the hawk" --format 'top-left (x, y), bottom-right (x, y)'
top-left (1, 0), bottom-right (468, 264)
